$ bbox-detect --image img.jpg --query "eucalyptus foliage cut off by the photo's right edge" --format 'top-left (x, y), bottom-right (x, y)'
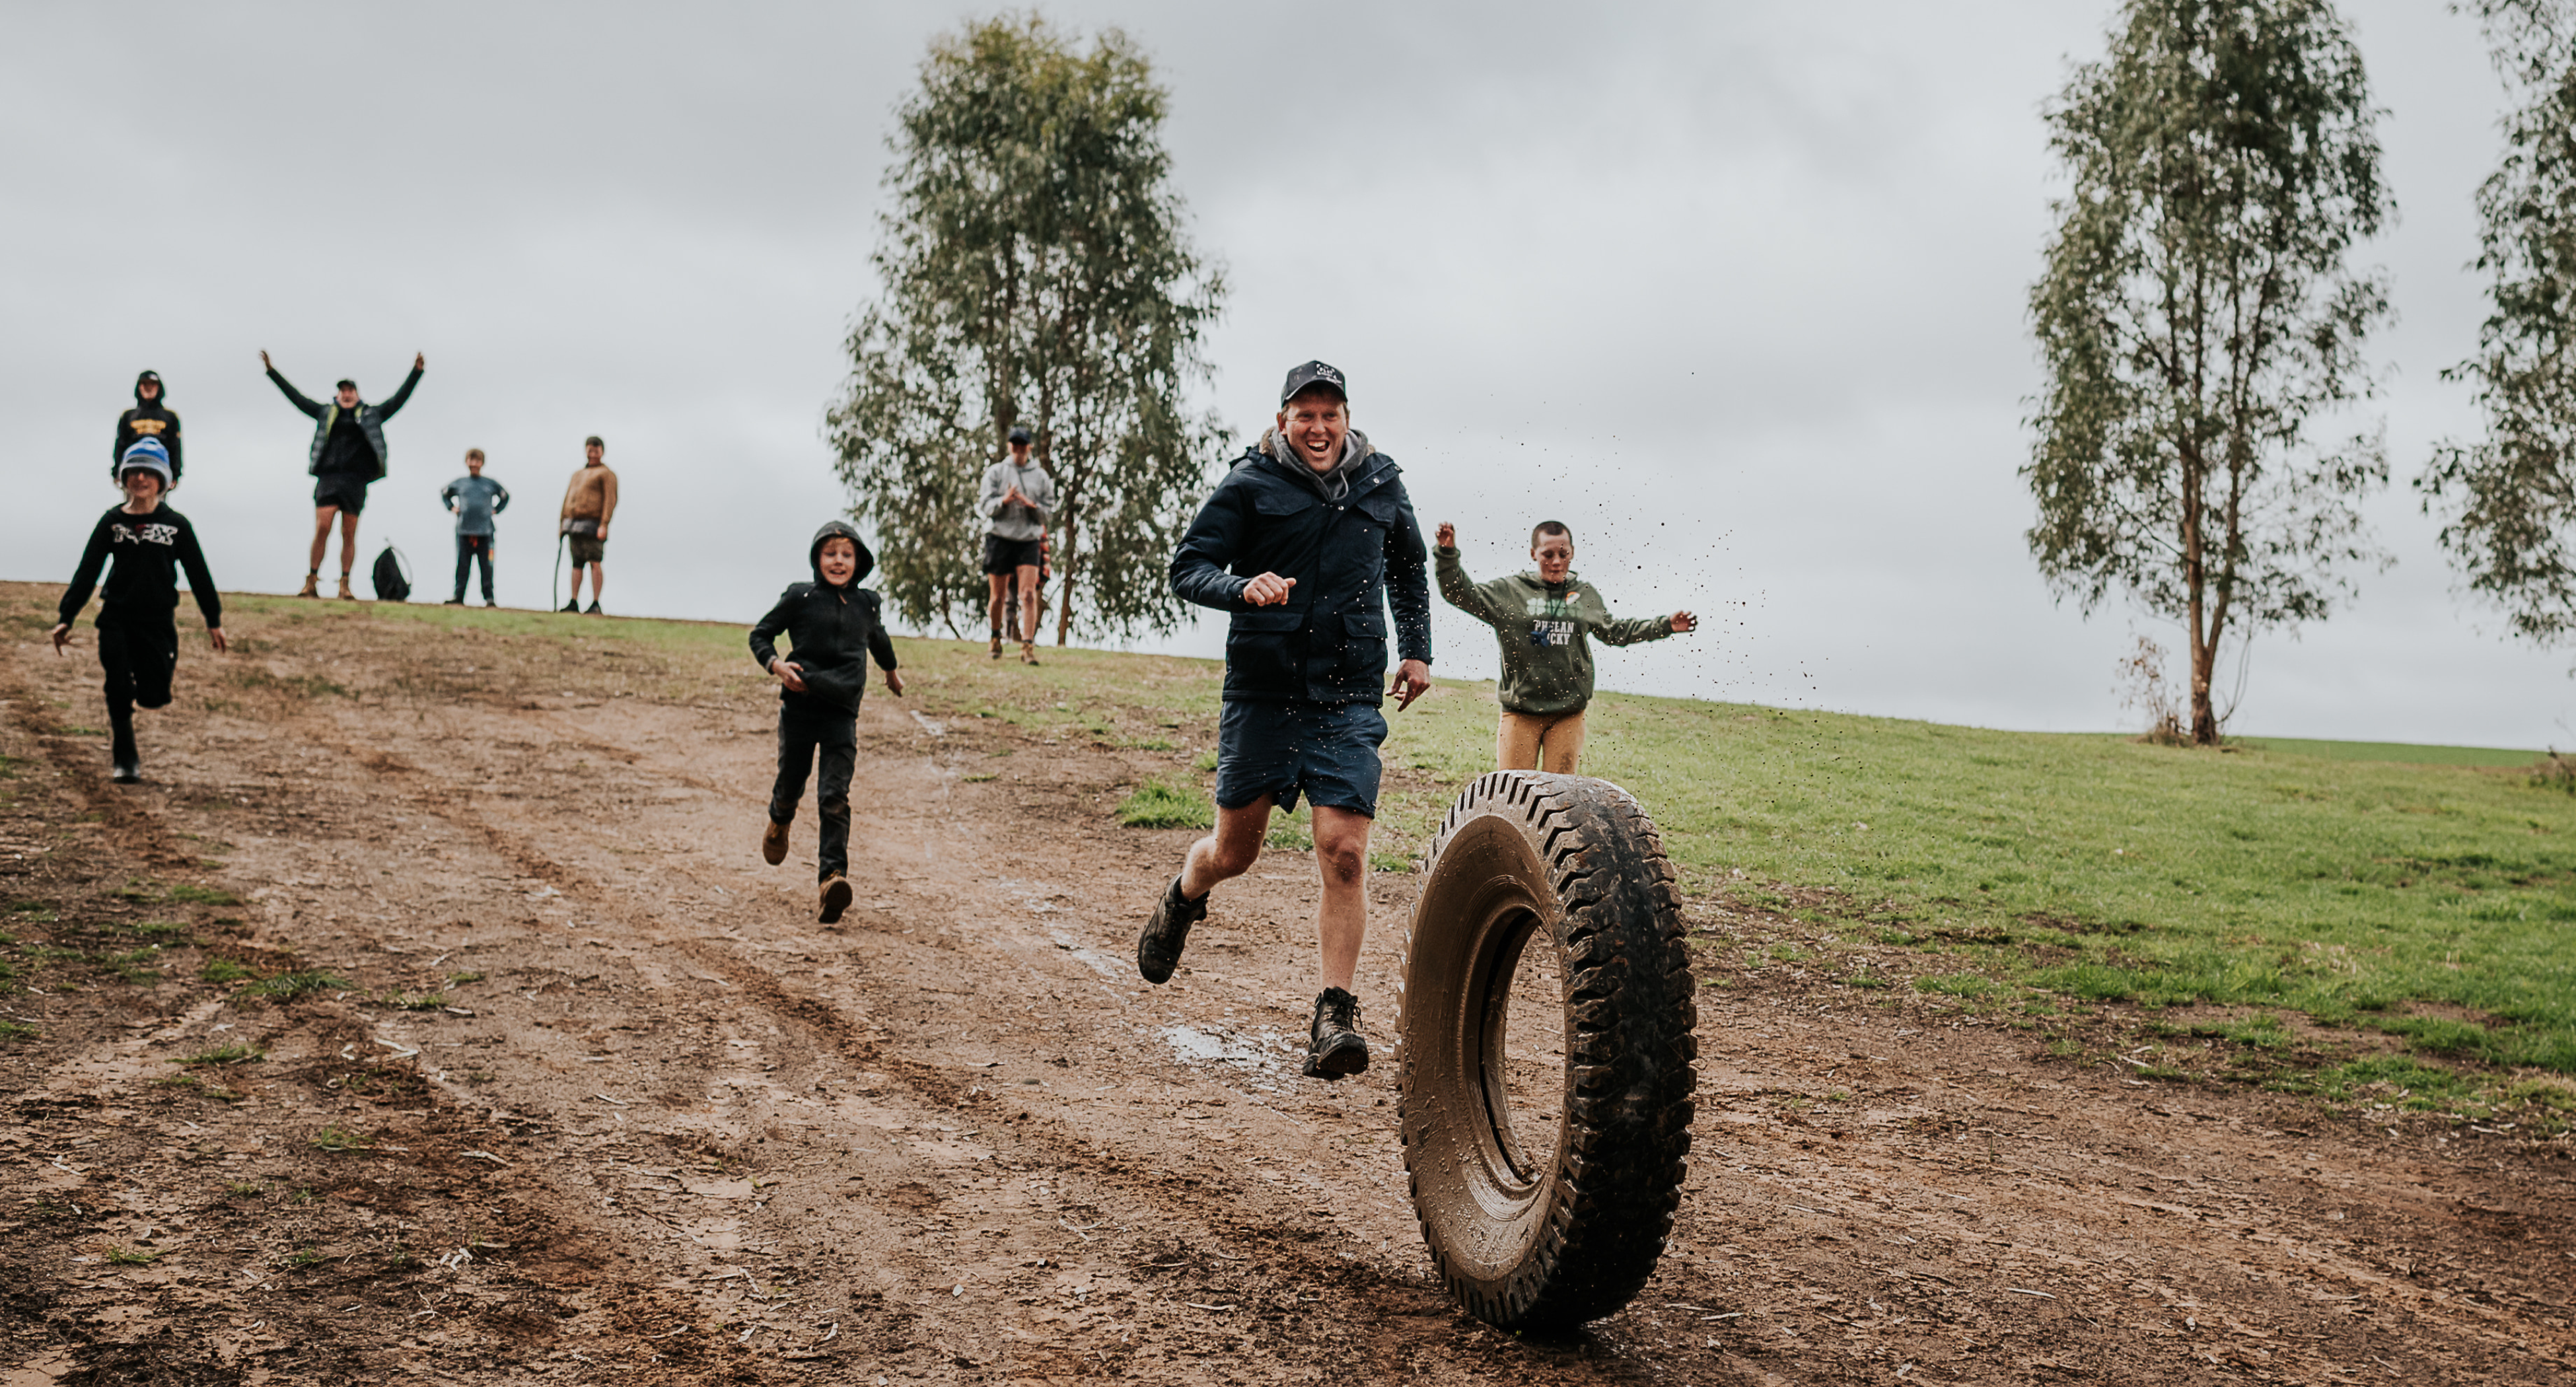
top-left (2416, 0), bottom-right (2576, 642)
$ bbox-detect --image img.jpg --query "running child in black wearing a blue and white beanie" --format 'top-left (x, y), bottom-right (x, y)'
top-left (54, 439), bottom-right (224, 784)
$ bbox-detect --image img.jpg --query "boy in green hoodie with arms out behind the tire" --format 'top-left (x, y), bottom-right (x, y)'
top-left (1435, 520), bottom-right (1700, 776)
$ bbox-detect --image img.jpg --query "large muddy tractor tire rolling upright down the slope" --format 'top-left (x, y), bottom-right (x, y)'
top-left (1402, 771), bottom-right (1698, 1330)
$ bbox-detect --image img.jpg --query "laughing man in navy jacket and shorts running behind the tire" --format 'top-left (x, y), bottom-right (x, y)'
top-left (1136, 361), bottom-right (1432, 1078)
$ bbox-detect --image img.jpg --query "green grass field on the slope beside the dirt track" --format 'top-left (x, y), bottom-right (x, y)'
top-left (25, 583), bottom-right (2576, 1073)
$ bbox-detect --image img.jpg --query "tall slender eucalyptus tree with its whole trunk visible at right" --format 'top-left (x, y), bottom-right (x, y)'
top-left (2022, 0), bottom-right (2396, 745)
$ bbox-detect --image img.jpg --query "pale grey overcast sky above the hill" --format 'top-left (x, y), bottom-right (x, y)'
top-left (0, 0), bottom-right (2576, 748)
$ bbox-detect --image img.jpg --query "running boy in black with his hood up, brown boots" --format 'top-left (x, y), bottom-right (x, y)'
top-left (752, 520), bottom-right (904, 925)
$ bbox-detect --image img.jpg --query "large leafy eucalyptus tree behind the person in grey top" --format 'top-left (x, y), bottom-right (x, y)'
top-left (827, 15), bottom-right (1224, 645)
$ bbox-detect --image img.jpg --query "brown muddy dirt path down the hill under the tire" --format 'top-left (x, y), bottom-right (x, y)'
top-left (0, 588), bottom-right (2576, 1384)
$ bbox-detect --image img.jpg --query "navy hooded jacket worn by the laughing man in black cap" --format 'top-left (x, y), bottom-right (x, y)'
top-left (1172, 443), bottom-right (1432, 704)
